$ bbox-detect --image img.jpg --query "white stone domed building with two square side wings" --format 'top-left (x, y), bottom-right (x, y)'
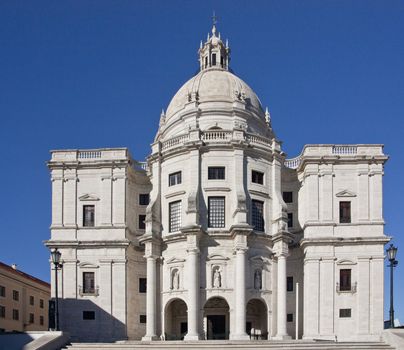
top-left (46, 26), bottom-right (389, 340)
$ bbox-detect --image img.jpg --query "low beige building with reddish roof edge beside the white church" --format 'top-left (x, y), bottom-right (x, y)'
top-left (0, 262), bottom-right (50, 332)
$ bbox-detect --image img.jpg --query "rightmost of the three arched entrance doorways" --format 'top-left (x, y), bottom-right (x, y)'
top-left (246, 299), bottom-right (268, 340)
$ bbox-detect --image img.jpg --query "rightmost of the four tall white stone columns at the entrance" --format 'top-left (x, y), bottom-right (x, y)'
top-left (275, 253), bottom-right (290, 339)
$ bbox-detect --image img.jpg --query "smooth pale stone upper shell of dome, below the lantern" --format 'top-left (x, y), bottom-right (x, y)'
top-left (166, 68), bottom-right (265, 122)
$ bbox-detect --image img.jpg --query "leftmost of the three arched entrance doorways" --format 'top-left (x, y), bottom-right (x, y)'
top-left (164, 299), bottom-right (188, 340)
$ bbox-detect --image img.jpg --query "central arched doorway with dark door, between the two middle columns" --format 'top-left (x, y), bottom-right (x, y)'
top-left (203, 297), bottom-right (230, 339)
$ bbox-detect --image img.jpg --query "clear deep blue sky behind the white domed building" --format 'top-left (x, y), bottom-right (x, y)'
top-left (0, 0), bottom-right (404, 322)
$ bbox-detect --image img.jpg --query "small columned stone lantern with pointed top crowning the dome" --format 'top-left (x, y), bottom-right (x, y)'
top-left (198, 13), bottom-right (230, 71)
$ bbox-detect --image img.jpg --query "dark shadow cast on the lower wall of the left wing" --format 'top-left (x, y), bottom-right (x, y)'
top-left (59, 299), bottom-right (128, 342)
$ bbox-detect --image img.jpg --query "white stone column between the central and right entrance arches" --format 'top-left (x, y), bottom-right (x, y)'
top-left (231, 247), bottom-right (249, 340)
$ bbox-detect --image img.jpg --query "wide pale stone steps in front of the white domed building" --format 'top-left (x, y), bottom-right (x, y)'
top-left (64, 340), bottom-right (399, 350)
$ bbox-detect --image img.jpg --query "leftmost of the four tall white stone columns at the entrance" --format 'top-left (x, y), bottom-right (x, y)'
top-left (142, 255), bottom-right (158, 341)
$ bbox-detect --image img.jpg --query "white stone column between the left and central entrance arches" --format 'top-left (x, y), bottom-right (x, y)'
top-left (184, 248), bottom-right (199, 340)
